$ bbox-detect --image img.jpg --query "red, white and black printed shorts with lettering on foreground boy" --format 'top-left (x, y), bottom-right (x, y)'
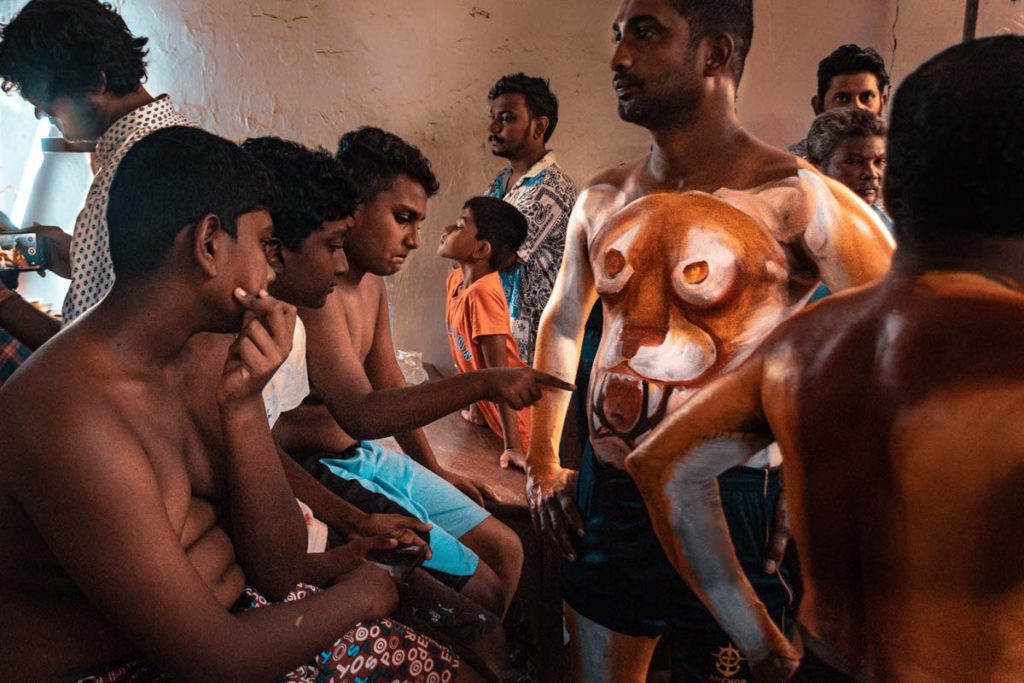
top-left (79, 584), bottom-right (459, 683)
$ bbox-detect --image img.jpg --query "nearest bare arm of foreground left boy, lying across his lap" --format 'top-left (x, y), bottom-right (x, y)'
top-left (3, 411), bottom-right (387, 680)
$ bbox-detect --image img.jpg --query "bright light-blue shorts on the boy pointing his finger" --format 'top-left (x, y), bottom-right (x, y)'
top-left (319, 441), bottom-right (490, 583)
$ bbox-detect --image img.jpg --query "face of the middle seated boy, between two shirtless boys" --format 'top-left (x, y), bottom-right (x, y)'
top-left (270, 216), bottom-right (352, 308)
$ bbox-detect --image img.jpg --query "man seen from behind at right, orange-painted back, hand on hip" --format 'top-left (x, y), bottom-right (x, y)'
top-left (627, 36), bottom-right (1024, 683)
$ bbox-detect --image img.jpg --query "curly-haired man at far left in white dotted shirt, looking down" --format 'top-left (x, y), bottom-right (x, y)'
top-left (0, 0), bottom-right (193, 325)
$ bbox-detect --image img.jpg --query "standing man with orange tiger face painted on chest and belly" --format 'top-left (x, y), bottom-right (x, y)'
top-left (527, 0), bottom-right (893, 681)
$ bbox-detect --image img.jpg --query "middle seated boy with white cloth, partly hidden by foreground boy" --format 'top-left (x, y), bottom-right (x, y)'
top-left (182, 137), bottom-right (430, 597)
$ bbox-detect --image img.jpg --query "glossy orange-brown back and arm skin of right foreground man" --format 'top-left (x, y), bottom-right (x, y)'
top-left (627, 266), bottom-right (1024, 682)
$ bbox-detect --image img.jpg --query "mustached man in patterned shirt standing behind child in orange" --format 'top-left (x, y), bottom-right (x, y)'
top-left (487, 74), bottom-right (577, 365)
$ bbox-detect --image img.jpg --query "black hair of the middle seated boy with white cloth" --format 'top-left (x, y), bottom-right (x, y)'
top-left (242, 136), bottom-right (358, 251)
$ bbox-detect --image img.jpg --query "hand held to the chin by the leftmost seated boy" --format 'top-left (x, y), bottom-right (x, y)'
top-left (217, 289), bottom-right (296, 405)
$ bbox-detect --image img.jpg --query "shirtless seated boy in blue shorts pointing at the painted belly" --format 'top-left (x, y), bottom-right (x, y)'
top-left (282, 128), bottom-right (569, 615)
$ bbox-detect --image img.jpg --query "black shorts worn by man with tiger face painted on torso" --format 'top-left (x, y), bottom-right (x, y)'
top-left (562, 442), bottom-right (798, 681)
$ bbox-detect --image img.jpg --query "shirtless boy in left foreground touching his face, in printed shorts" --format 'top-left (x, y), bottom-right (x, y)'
top-left (0, 128), bottom-right (457, 681)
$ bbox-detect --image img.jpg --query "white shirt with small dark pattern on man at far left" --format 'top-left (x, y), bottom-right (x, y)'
top-left (63, 95), bottom-right (196, 325)
